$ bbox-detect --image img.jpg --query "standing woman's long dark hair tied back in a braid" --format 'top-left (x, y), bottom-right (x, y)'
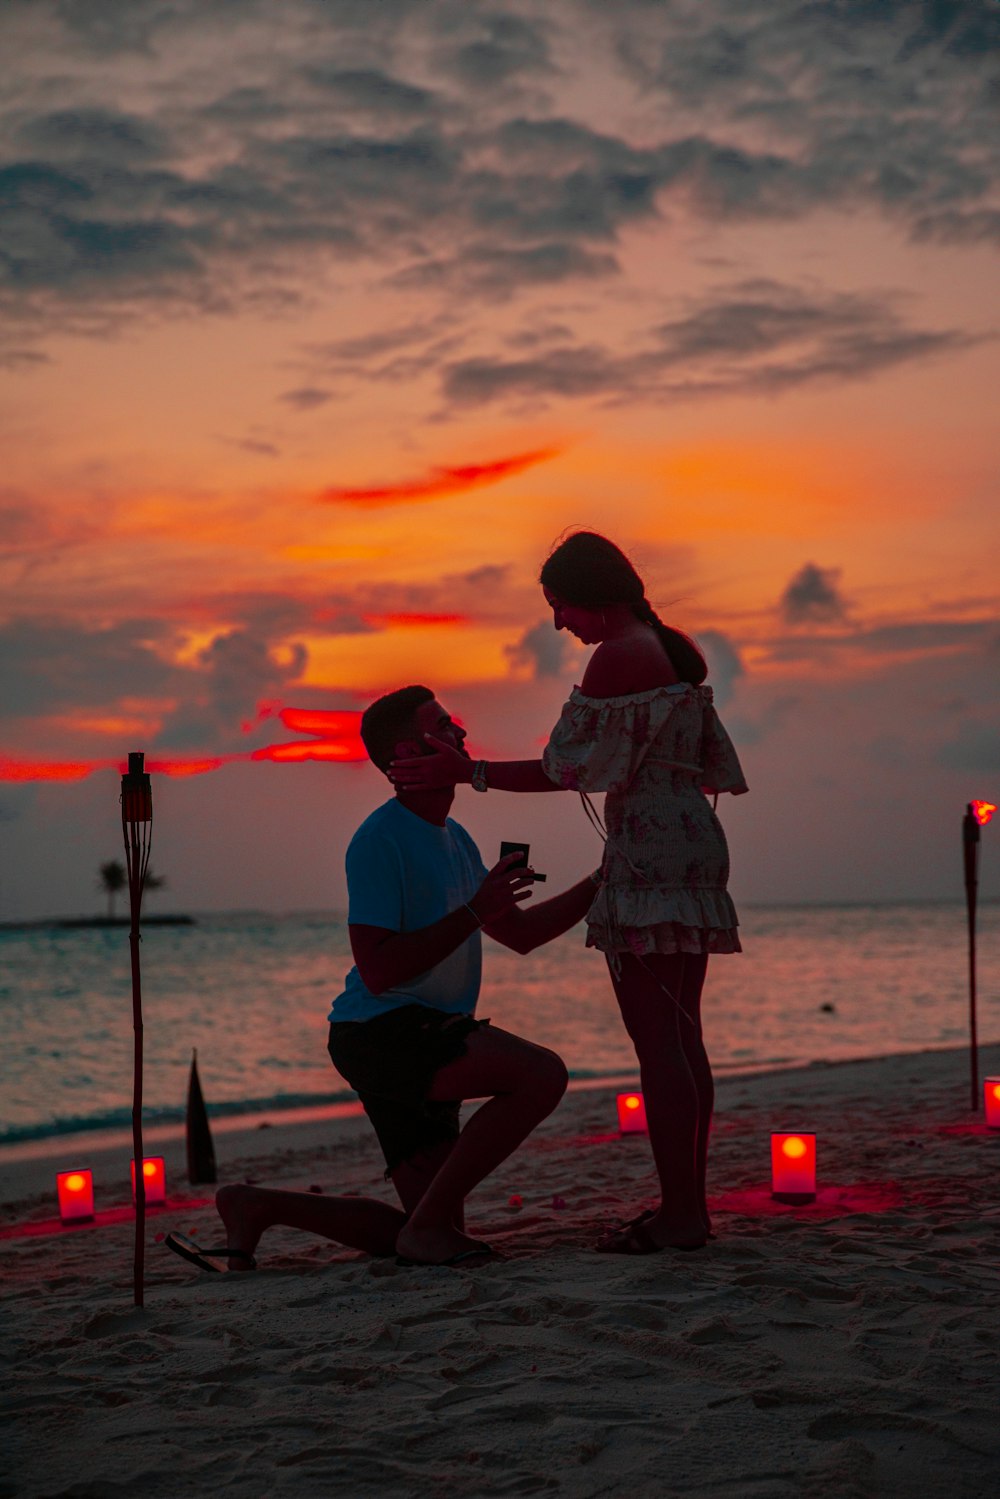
top-left (540, 531), bottom-right (708, 687)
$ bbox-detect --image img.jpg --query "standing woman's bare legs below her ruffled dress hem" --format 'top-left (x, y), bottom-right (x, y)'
top-left (612, 953), bottom-right (711, 1249)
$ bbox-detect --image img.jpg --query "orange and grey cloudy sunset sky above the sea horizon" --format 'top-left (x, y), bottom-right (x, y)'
top-left (0, 0), bottom-right (1000, 920)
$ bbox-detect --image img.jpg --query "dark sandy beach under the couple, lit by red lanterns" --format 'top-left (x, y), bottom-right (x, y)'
top-left (0, 1046), bottom-right (1000, 1499)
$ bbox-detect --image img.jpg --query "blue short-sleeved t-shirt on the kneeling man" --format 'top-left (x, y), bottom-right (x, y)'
top-left (328, 797), bottom-right (489, 1021)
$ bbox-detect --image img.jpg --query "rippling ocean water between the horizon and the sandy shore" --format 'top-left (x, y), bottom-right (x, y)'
top-left (0, 904), bottom-right (1000, 1145)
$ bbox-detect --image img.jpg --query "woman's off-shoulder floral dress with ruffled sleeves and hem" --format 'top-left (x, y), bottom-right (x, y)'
top-left (541, 682), bottom-right (747, 955)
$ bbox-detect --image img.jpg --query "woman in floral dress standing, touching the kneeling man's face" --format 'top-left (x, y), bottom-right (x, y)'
top-left (393, 531), bottom-right (747, 1255)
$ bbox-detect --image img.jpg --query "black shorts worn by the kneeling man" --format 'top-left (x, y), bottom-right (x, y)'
top-left (327, 1004), bottom-right (489, 1177)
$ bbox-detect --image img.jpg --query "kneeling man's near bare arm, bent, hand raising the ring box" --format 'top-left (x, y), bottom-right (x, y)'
top-left (348, 853), bottom-right (530, 995)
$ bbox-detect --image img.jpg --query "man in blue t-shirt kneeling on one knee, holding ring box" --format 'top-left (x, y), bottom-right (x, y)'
top-left (172, 687), bottom-right (595, 1270)
